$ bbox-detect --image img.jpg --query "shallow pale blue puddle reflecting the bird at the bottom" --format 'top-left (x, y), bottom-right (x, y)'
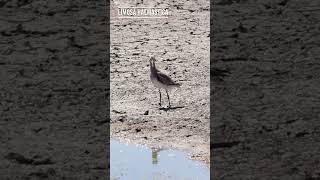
top-left (110, 140), bottom-right (210, 180)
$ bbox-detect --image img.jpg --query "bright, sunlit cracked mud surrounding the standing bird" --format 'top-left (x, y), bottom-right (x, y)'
top-left (110, 1), bottom-right (210, 163)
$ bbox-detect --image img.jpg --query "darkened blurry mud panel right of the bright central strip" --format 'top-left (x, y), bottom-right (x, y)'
top-left (211, 0), bottom-right (320, 180)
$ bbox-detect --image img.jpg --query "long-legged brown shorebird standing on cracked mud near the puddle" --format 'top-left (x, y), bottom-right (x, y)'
top-left (149, 57), bottom-right (180, 108)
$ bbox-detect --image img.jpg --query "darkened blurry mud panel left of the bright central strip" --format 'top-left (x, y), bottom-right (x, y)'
top-left (0, 0), bottom-right (108, 180)
